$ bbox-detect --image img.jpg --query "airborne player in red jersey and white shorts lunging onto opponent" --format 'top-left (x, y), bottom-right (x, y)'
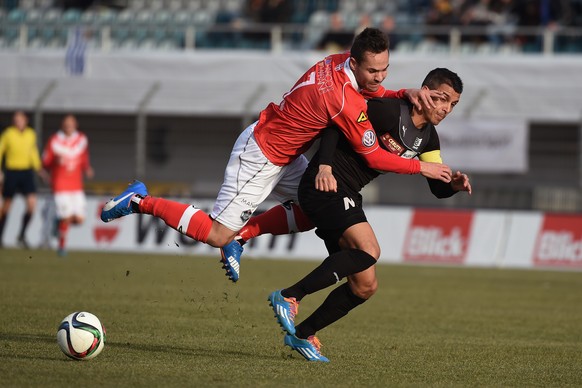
top-left (101, 28), bottom-right (451, 280)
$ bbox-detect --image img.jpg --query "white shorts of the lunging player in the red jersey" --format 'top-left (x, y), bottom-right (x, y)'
top-left (210, 122), bottom-right (308, 231)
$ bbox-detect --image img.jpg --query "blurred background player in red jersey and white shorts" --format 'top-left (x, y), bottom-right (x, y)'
top-left (42, 115), bottom-right (93, 256)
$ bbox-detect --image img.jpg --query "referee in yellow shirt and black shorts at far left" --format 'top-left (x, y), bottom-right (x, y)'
top-left (0, 111), bottom-right (41, 248)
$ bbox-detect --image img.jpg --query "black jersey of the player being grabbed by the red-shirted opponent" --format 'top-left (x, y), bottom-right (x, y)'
top-left (307, 98), bottom-right (440, 192)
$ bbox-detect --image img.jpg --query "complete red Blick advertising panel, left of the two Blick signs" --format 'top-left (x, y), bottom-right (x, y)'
top-left (403, 210), bottom-right (473, 264)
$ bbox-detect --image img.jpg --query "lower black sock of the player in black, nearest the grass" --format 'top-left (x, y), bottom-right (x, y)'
top-left (295, 283), bottom-right (366, 338)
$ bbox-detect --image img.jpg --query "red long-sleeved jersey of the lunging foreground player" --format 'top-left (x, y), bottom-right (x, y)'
top-left (254, 53), bottom-right (420, 174)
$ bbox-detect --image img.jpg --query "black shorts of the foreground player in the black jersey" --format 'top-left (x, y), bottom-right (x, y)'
top-left (298, 172), bottom-right (368, 253)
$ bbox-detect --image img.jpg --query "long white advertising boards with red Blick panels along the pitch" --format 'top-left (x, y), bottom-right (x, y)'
top-left (4, 197), bottom-right (582, 270)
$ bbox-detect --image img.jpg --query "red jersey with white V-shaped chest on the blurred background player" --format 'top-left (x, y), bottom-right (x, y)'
top-left (42, 131), bottom-right (89, 192)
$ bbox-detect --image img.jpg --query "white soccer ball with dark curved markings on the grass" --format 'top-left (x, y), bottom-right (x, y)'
top-left (57, 311), bottom-right (105, 360)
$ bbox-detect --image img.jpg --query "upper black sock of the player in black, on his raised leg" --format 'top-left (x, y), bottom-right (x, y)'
top-left (281, 249), bottom-right (376, 301)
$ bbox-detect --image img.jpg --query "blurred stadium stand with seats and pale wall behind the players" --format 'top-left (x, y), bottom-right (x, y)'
top-left (0, 0), bottom-right (582, 212)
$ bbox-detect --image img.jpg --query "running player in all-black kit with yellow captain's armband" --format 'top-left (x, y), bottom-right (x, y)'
top-left (269, 68), bottom-right (471, 361)
